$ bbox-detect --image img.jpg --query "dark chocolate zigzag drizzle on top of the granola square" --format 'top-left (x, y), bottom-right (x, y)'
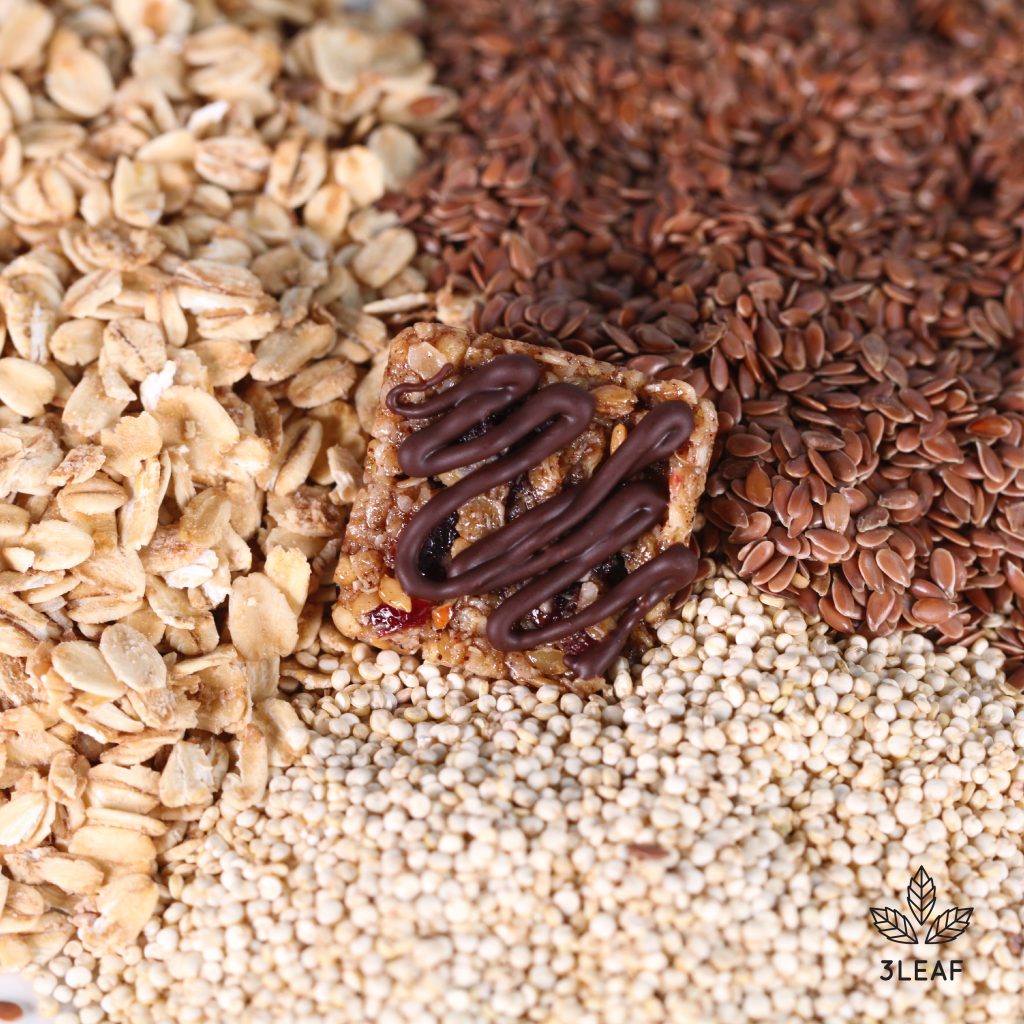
top-left (385, 355), bottom-right (696, 678)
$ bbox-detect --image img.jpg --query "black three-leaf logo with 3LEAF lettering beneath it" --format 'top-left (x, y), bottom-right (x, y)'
top-left (871, 867), bottom-right (974, 981)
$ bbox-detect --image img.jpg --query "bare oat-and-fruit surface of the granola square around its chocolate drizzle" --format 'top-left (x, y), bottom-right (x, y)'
top-left (334, 324), bottom-right (716, 689)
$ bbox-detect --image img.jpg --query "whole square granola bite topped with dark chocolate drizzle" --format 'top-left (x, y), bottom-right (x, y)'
top-left (333, 324), bottom-right (717, 690)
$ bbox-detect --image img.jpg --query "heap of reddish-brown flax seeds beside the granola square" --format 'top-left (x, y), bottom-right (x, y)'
top-left (396, 0), bottom-right (1024, 681)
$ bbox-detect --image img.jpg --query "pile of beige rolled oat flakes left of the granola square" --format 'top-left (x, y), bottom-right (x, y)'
top-left (0, 0), bottom-right (453, 969)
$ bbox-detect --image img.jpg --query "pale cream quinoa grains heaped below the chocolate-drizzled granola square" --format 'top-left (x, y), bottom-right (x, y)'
top-left (24, 579), bottom-right (1024, 1024)
